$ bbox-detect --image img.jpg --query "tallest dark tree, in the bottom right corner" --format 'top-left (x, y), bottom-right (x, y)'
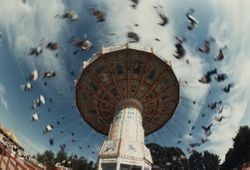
top-left (222, 126), bottom-right (250, 170)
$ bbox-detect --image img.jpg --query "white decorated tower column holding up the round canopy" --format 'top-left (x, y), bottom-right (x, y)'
top-left (98, 99), bottom-right (152, 170)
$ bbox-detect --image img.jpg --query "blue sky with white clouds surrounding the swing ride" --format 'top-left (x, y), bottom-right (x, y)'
top-left (0, 0), bottom-right (250, 160)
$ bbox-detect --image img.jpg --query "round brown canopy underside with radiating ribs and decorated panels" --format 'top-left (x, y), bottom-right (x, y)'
top-left (76, 44), bottom-right (179, 135)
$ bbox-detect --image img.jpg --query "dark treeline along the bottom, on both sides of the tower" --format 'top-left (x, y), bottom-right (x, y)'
top-left (34, 126), bottom-right (250, 170)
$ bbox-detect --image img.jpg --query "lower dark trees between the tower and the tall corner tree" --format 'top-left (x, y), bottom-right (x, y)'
top-left (147, 143), bottom-right (220, 170)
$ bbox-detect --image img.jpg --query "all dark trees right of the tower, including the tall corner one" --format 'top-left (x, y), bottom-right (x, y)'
top-left (147, 126), bottom-right (250, 170)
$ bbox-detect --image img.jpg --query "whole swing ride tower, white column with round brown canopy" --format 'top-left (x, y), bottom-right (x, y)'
top-left (76, 44), bottom-right (179, 170)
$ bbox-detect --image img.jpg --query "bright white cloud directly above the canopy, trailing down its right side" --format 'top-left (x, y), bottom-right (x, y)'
top-left (103, 1), bottom-right (208, 109)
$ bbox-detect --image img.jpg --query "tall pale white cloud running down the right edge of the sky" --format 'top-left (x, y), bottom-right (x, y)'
top-left (208, 0), bottom-right (250, 160)
